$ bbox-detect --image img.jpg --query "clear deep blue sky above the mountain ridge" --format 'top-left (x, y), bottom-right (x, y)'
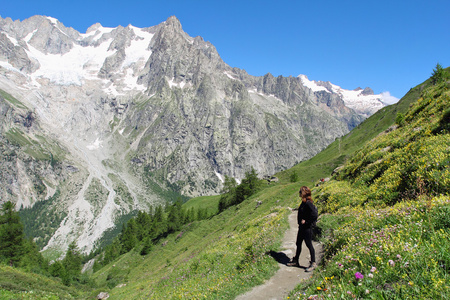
top-left (0, 0), bottom-right (450, 98)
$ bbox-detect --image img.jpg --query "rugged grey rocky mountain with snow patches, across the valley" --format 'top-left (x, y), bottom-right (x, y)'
top-left (0, 16), bottom-right (382, 251)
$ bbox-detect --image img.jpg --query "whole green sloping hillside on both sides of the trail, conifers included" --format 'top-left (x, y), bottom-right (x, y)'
top-left (0, 67), bottom-right (450, 299)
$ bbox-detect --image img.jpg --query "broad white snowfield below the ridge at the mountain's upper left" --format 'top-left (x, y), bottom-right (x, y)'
top-left (0, 22), bottom-right (154, 96)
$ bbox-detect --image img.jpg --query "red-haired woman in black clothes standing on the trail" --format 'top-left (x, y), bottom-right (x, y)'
top-left (287, 186), bottom-right (317, 272)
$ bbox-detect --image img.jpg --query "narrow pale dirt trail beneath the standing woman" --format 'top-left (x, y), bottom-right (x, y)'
top-left (236, 211), bottom-right (323, 300)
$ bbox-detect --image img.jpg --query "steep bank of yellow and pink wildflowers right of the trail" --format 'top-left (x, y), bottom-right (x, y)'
top-left (291, 76), bottom-right (450, 299)
